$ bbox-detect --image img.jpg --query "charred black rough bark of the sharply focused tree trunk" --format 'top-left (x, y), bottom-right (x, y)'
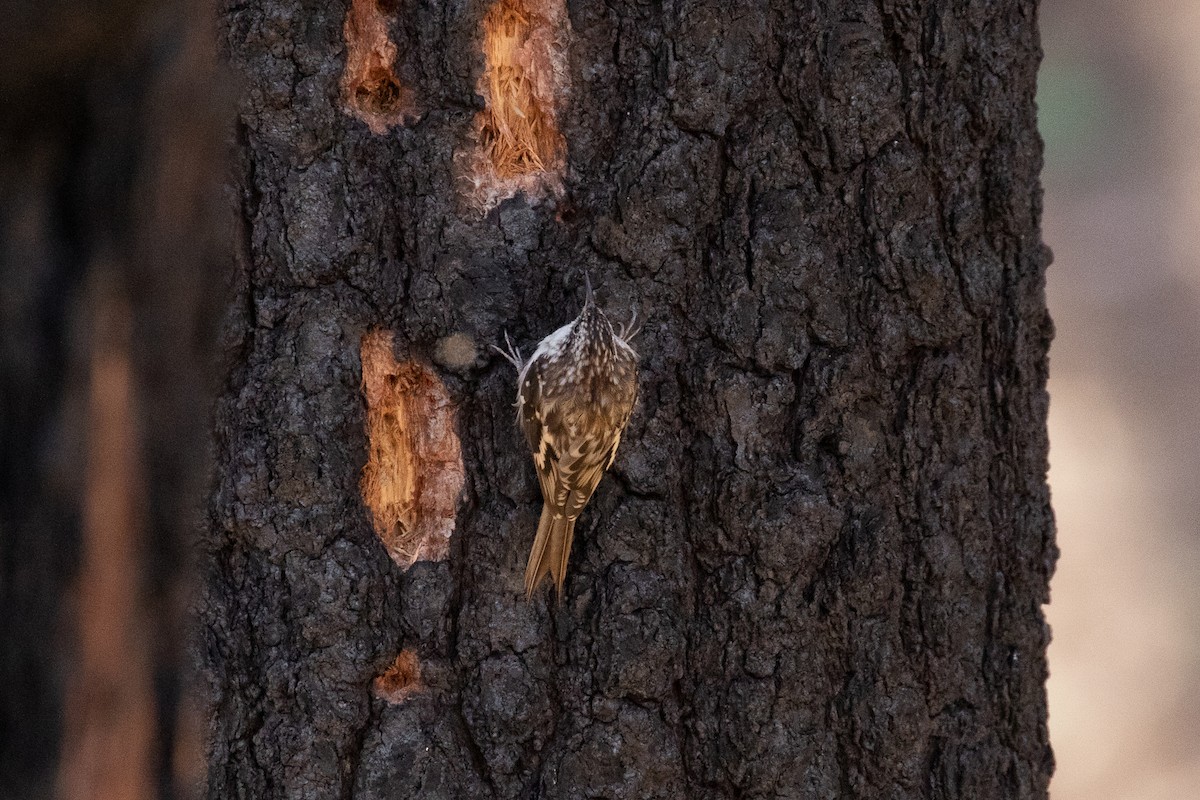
top-left (205, 0), bottom-right (1055, 800)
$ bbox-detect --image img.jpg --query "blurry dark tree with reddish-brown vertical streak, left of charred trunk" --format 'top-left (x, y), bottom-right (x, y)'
top-left (0, 0), bottom-right (228, 800)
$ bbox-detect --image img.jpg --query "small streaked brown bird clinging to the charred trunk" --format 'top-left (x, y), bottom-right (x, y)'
top-left (493, 276), bottom-right (640, 602)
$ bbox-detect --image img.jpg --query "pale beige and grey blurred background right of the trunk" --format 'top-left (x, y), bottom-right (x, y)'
top-left (1038, 0), bottom-right (1200, 800)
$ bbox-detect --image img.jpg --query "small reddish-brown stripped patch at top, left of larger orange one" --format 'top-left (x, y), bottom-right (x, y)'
top-left (342, 0), bottom-right (416, 134)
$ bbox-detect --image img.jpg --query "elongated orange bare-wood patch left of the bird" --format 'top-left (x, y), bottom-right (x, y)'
top-left (361, 331), bottom-right (464, 569)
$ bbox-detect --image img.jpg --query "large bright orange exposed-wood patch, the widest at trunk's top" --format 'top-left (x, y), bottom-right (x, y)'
top-left (467, 0), bottom-right (570, 209)
